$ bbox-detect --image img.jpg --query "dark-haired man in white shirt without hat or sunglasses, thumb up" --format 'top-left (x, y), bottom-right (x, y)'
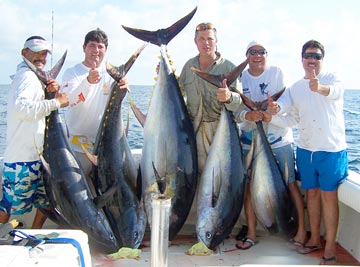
top-left (62, 28), bottom-right (129, 175)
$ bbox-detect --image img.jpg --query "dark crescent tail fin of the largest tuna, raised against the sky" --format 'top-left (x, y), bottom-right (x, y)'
top-left (121, 7), bottom-right (197, 46)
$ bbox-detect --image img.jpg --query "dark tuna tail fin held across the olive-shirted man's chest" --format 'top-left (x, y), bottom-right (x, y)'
top-left (191, 59), bottom-right (248, 87)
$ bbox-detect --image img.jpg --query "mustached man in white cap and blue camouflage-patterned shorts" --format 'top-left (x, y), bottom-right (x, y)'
top-left (0, 36), bottom-right (68, 228)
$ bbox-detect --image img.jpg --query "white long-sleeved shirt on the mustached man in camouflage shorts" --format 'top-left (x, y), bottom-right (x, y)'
top-left (4, 62), bottom-right (60, 163)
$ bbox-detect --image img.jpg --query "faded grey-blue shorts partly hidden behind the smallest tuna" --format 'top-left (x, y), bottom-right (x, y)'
top-left (244, 144), bottom-right (295, 184)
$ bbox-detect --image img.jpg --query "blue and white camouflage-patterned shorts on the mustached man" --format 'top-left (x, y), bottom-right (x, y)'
top-left (0, 161), bottom-right (48, 215)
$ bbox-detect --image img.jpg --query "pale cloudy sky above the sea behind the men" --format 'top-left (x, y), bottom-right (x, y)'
top-left (0, 0), bottom-right (360, 89)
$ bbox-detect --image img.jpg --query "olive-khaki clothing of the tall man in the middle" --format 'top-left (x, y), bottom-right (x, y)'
top-left (179, 53), bottom-right (242, 173)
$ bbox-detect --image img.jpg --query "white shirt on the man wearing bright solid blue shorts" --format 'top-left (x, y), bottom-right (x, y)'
top-left (278, 72), bottom-right (346, 152)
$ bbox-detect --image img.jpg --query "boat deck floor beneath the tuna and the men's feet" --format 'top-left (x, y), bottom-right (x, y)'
top-left (92, 228), bottom-right (360, 267)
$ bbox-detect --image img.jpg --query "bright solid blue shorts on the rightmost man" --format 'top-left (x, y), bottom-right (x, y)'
top-left (296, 148), bottom-right (348, 191)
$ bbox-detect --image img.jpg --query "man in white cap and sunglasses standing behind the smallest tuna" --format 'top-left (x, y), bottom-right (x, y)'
top-left (236, 41), bottom-right (306, 250)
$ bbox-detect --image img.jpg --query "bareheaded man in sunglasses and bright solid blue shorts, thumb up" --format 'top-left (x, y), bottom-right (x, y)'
top-left (268, 40), bottom-right (348, 265)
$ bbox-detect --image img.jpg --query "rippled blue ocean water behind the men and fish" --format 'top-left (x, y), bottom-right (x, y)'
top-left (0, 85), bottom-right (360, 173)
